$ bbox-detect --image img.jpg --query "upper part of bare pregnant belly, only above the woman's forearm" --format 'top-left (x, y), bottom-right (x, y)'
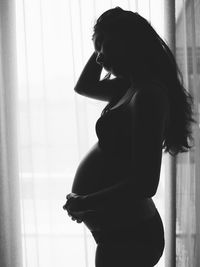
top-left (72, 143), bottom-right (130, 194)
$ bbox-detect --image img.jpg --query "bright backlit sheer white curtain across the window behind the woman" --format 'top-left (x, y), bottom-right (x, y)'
top-left (0, 0), bottom-right (164, 267)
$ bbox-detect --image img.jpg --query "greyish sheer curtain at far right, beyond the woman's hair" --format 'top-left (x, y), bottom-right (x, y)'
top-left (176, 0), bottom-right (200, 267)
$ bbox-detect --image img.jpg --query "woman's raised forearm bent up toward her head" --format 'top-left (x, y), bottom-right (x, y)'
top-left (74, 52), bottom-right (102, 92)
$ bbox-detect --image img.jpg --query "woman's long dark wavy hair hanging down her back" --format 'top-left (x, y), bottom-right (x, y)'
top-left (93, 7), bottom-right (195, 155)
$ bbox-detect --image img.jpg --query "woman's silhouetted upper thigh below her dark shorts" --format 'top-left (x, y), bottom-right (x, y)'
top-left (95, 243), bottom-right (160, 267)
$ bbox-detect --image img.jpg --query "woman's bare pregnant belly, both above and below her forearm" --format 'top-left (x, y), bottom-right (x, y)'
top-left (71, 143), bottom-right (155, 230)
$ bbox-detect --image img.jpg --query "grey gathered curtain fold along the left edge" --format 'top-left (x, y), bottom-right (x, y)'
top-left (0, 1), bottom-right (22, 267)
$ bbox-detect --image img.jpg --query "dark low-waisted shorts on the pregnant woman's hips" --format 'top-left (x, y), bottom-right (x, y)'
top-left (91, 210), bottom-right (165, 254)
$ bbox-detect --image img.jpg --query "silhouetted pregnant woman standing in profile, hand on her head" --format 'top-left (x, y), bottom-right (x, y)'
top-left (63, 7), bottom-right (193, 267)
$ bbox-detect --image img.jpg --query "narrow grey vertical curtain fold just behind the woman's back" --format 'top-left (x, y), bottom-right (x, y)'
top-left (164, 0), bottom-right (176, 267)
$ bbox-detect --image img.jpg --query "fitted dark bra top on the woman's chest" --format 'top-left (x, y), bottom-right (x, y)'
top-left (96, 90), bottom-right (136, 159)
